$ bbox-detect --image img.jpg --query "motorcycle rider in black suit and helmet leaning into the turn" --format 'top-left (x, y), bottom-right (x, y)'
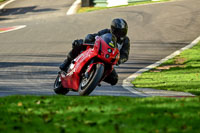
top-left (60, 18), bottom-right (130, 85)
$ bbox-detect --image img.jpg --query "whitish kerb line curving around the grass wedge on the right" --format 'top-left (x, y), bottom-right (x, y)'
top-left (122, 36), bottom-right (200, 96)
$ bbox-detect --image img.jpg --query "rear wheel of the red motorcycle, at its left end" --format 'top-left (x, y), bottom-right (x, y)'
top-left (54, 75), bottom-right (69, 95)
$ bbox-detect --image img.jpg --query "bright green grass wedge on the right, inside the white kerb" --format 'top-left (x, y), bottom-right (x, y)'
top-left (132, 43), bottom-right (200, 95)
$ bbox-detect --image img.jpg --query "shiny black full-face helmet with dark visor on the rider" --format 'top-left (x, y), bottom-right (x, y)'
top-left (111, 18), bottom-right (128, 40)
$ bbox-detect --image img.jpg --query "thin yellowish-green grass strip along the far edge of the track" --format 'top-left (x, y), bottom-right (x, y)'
top-left (78, 0), bottom-right (171, 13)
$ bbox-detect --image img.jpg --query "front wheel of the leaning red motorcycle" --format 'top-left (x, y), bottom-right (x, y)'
top-left (79, 64), bottom-right (104, 96)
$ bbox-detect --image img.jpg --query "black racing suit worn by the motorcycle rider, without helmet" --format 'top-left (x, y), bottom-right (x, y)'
top-left (67, 29), bottom-right (130, 85)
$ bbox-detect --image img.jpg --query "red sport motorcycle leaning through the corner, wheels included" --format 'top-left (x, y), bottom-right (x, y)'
top-left (54, 33), bottom-right (120, 95)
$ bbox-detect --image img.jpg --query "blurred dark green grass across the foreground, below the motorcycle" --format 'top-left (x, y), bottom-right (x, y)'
top-left (0, 96), bottom-right (200, 133)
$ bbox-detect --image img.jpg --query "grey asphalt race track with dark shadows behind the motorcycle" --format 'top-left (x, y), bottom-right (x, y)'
top-left (0, 0), bottom-right (200, 97)
